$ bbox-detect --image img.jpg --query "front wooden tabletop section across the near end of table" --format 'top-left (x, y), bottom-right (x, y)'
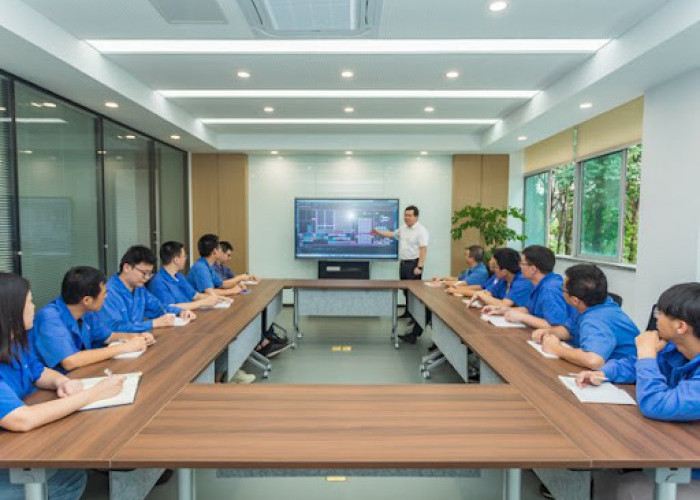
top-left (112, 384), bottom-right (590, 469)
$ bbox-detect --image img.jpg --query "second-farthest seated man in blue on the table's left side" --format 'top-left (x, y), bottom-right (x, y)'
top-left (187, 234), bottom-right (245, 297)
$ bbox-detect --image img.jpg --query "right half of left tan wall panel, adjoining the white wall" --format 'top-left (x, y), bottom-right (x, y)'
top-left (219, 154), bottom-right (248, 273)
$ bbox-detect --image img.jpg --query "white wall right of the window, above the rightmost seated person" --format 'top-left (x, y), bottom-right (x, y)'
top-left (634, 70), bottom-right (700, 321)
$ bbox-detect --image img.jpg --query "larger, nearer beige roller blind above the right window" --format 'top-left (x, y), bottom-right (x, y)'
top-left (576, 97), bottom-right (644, 159)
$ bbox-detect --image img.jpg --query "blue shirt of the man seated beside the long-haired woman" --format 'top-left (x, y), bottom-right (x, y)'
top-left (29, 297), bottom-right (112, 373)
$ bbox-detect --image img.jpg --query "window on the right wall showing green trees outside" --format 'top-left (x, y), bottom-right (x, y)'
top-left (525, 144), bottom-right (642, 264)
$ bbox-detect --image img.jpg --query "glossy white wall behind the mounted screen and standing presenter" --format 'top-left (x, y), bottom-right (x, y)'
top-left (248, 155), bottom-right (452, 290)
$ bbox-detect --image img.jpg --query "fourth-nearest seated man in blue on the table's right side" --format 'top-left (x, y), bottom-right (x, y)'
top-left (472, 248), bottom-right (532, 308)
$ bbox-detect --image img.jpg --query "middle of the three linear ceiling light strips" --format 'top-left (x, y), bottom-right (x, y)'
top-left (164, 89), bottom-right (539, 99)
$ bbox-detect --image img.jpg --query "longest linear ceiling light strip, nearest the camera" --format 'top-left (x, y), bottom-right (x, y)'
top-left (85, 38), bottom-right (610, 55)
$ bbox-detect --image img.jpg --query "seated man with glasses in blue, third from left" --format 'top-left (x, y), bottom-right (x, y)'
top-left (99, 245), bottom-right (196, 333)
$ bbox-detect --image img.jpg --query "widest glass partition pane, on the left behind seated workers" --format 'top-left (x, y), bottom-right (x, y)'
top-left (15, 83), bottom-right (100, 306)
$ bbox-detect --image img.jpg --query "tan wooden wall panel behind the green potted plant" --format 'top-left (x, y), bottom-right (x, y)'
top-left (450, 155), bottom-right (509, 276)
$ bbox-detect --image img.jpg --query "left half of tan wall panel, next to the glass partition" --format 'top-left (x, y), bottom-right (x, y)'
top-left (192, 154), bottom-right (219, 249)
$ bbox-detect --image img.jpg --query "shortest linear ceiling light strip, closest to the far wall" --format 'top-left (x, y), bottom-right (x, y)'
top-left (199, 118), bottom-right (499, 125)
